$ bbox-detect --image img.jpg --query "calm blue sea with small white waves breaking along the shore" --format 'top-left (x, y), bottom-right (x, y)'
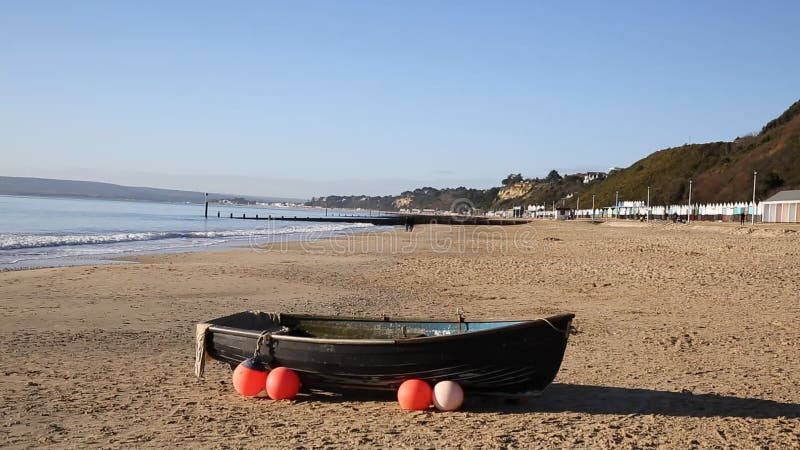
top-left (0, 195), bottom-right (378, 270)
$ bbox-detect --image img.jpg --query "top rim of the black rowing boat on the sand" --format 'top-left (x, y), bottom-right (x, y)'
top-left (203, 313), bottom-right (575, 345)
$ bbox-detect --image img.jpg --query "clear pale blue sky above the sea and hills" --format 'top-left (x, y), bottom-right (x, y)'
top-left (0, 0), bottom-right (800, 197)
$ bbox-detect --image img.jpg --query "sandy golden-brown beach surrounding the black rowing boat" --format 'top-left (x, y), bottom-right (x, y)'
top-left (0, 222), bottom-right (800, 448)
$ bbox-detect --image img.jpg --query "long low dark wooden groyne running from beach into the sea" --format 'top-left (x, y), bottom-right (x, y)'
top-left (229, 213), bottom-right (530, 226)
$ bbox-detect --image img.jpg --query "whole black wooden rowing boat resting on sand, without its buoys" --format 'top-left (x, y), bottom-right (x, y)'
top-left (196, 311), bottom-right (574, 396)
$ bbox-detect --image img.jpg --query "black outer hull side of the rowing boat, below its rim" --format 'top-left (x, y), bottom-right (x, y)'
top-left (206, 314), bottom-right (573, 395)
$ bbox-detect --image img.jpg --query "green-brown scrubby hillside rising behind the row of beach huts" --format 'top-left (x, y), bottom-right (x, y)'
top-left (581, 101), bottom-right (800, 205)
